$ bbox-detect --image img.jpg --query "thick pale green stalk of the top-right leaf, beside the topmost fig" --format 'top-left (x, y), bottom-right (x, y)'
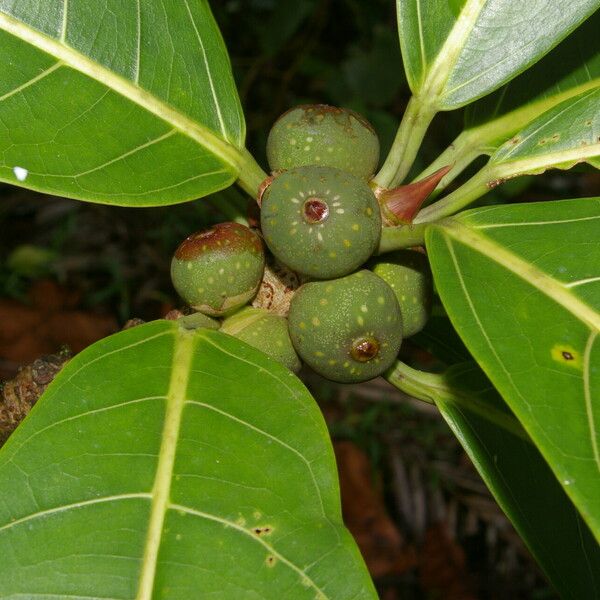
top-left (374, 96), bottom-right (436, 188)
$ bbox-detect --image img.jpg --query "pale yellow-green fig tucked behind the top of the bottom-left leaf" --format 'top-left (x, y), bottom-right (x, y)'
top-left (221, 307), bottom-right (302, 373)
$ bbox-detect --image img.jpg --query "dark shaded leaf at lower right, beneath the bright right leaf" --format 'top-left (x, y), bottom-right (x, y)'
top-left (435, 364), bottom-right (600, 600)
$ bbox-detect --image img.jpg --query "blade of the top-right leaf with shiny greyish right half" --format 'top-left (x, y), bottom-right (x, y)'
top-left (396, 0), bottom-right (598, 110)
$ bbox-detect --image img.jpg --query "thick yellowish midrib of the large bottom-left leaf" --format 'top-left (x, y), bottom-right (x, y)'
top-left (137, 329), bottom-right (195, 600)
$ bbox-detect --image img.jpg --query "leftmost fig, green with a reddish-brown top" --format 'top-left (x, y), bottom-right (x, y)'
top-left (171, 223), bottom-right (265, 317)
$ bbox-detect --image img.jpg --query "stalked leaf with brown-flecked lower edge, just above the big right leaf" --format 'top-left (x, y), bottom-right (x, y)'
top-left (415, 87), bottom-right (600, 223)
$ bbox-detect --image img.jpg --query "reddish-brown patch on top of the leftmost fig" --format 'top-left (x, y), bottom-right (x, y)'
top-left (175, 222), bottom-right (263, 260)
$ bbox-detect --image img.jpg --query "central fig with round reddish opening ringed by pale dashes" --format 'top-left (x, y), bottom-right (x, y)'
top-left (261, 166), bottom-right (381, 279)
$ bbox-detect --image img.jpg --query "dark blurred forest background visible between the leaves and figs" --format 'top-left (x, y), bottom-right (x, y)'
top-left (0, 0), bottom-right (600, 600)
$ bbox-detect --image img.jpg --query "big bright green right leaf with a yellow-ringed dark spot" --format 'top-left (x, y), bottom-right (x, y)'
top-left (427, 198), bottom-right (600, 538)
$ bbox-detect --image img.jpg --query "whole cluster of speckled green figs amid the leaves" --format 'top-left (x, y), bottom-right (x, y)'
top-left (171, 105), bottom-right (432, 383)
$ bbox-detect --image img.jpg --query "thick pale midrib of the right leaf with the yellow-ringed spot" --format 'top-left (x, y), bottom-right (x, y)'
top-left (442, 220), bottom-right (600, 331)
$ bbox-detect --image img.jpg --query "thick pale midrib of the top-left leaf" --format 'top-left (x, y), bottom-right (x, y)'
top-left (0, 12), bottom-right (241, 171)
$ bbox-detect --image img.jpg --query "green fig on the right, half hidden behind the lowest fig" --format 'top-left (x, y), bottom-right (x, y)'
top-left (370, 250), bottom-right (433, 337)
